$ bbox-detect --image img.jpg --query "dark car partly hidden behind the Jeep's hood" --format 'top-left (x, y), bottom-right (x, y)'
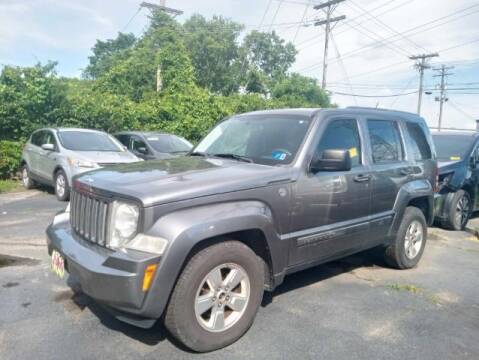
top-left (114, 131), bottom-right (193, 160)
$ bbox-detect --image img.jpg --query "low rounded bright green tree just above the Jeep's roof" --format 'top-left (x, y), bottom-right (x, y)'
top-left (272, 73), bottom-right (331, 107)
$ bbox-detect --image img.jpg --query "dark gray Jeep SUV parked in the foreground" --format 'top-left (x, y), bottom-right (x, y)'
top-left (47, 108), bottom-right (437, 352)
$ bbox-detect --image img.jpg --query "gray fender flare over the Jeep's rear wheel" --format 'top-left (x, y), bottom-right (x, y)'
top-left (389, 179), bottom-right (434, 237)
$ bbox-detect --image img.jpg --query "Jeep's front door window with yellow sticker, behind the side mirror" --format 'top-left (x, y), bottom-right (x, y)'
top-left (315, 119), bottom-right (361, 167)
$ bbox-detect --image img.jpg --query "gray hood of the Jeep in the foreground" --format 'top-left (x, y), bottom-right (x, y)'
top-left (74, 156), bottom-right (292, 206)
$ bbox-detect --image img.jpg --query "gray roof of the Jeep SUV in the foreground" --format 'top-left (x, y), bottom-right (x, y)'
top-left (237, 106), bottom-right (422, 121)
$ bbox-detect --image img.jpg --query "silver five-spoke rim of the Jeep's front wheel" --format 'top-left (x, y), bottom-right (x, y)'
top-left (195, 263), bottom-right (251, 332)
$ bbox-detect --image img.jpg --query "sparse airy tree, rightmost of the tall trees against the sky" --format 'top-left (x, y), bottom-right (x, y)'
top-left (241, 30), bottom-right (297, 79)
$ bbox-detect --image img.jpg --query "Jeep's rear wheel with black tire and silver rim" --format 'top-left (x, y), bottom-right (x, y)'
top-left (385, 207), bottom-right (427, 269)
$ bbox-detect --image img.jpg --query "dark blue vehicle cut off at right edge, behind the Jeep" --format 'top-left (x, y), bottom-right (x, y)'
top-left (433, 132), bottom-right (479, 230)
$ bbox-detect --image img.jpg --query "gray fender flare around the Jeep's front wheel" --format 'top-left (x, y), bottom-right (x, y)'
top-left (143, 200), bottom-right (288, 318)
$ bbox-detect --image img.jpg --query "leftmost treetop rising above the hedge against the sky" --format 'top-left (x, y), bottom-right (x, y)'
top-left (83, 32), bottom-right (136, 79)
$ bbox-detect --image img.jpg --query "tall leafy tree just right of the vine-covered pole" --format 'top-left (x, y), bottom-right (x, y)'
top-left (183, 15), bottom-right (243, 95)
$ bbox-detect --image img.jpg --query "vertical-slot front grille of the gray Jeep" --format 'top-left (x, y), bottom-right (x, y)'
top-left (70, 190), bottom-right (109, 247)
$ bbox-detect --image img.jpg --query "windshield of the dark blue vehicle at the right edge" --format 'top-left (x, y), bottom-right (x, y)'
top-left (432, 135), bottom-right (474, 161)
